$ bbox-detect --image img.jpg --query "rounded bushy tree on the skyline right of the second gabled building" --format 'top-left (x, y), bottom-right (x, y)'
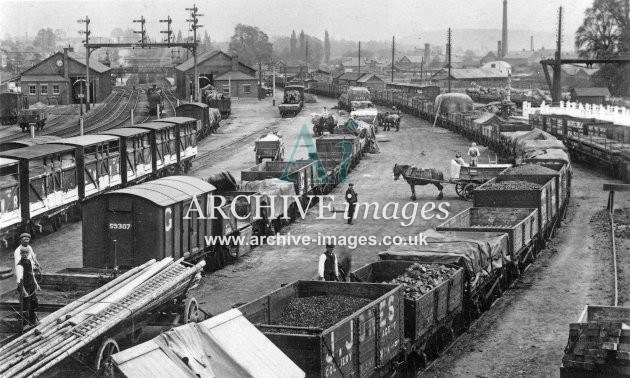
top-left (230, 24), bottom-right (273, 65)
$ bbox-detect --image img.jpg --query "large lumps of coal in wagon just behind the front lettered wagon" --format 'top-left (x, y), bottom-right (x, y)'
top-left (384, 263), bottom-right (457, 300)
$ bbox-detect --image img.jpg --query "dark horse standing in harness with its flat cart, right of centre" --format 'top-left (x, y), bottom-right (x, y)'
top-left (394, 162), bottom-right (512, 201)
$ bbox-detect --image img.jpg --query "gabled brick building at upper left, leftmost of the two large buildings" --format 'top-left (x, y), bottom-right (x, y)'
top-left (20, 47), bottom-right (112, 105)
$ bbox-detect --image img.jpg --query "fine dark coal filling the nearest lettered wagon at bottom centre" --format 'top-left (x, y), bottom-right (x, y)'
top-left (274, 295), bottom-right (372, 329)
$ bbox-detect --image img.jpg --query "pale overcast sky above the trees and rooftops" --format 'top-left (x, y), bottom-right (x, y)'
top-left (0, 0), bottom-right (593, 45)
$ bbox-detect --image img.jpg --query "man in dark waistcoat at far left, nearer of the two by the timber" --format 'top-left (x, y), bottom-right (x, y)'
top-left (15, 246), bottom-right (40, 325)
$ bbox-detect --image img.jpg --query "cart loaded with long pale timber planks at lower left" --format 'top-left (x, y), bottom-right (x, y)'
top-left (0, 258), bottom-right (204, 377)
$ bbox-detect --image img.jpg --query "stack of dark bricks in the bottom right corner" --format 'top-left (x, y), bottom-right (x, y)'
top-left (562, 321), bottom-right (630, 375)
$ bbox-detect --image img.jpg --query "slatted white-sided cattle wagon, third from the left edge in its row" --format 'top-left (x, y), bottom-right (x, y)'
top-left (49, 134), bottom-right (123, 201)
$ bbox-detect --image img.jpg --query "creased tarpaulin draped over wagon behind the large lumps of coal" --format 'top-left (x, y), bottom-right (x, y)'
top-left (379, 230), bottom-right (510, 289)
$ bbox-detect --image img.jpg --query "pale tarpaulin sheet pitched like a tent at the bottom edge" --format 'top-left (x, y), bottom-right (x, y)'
top-left (112, 309), bottom-right (305, 378)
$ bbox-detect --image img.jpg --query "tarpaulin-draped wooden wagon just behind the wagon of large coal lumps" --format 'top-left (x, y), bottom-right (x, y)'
top-left (378, 230), bottom-right (509, 319)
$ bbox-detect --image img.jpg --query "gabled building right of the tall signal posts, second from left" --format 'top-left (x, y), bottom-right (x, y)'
top-left (175, 50), bottom-right (258, 98)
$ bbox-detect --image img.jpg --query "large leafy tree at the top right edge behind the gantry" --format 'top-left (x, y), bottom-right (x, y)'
top-left (575, 0), bottom-right (630, 95)
